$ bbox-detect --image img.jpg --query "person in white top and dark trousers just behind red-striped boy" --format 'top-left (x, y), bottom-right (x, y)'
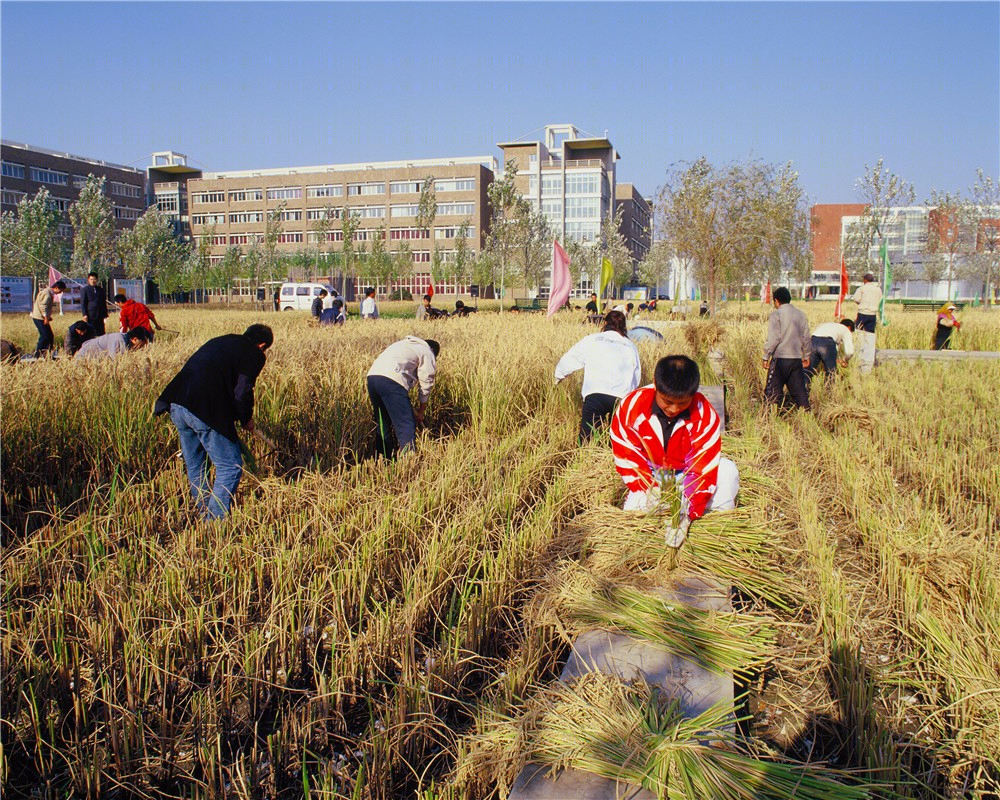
top-left (555, 311), bottom-right (642, 444)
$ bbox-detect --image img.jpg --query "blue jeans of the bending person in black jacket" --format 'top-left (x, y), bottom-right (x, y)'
top-left (170, 403), bottom-right (243, 519)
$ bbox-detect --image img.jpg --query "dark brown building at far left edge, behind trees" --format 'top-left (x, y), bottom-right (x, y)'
top-left (0, 139), bottom-right (146, 240)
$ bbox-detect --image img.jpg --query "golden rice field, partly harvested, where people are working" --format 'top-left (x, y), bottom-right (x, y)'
top-left (0, 303), bottom-right (1000, 800)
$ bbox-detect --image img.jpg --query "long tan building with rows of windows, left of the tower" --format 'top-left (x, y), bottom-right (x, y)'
top-left (187, 156), bottom-right (496, 295)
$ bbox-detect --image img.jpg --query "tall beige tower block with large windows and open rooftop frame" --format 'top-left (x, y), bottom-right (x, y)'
top-left (497, 124), bottom-right (650, 296)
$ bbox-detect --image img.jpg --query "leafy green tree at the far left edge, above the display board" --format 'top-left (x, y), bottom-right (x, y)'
top-left (0, 188), bottom-right (64, 279)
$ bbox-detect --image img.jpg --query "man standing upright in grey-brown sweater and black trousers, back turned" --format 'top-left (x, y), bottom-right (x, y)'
top-left (764, 286), bottom-right (812, 411)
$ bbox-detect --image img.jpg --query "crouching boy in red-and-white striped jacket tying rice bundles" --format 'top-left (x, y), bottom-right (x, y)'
top-left (611, 355), bottom-right (740, 547)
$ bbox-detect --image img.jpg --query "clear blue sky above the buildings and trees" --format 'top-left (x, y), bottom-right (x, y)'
top-left (0, 2), bottom-right (1000, 202)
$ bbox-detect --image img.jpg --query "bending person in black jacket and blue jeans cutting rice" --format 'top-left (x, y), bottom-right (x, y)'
top-left (153, 325), bottom-right (274, 519)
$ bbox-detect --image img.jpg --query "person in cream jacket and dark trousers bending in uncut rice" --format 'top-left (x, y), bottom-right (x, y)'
top-left (367, 336), bottom-right (441, 458)
